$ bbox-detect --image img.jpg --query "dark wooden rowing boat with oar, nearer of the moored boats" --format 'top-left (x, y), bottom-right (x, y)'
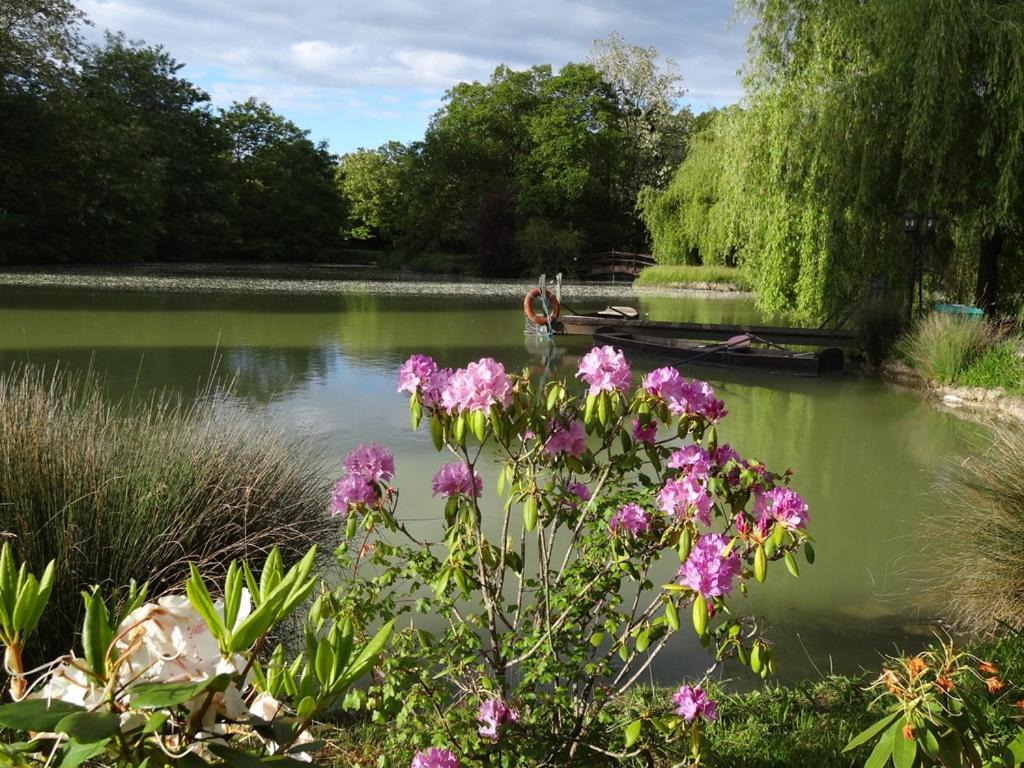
top-left (594, 326), bottom-right (843, 376)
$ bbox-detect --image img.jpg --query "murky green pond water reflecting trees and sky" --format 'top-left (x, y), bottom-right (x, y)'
top-left (0, 286), bottom-right (978, 681)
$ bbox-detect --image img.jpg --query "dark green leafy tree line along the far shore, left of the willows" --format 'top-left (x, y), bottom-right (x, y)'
top-left (0, 0), bottom-right (694, 275)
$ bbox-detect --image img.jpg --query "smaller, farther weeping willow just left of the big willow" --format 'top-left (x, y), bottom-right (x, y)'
top-left (637, 106), bottom-right (744, 265)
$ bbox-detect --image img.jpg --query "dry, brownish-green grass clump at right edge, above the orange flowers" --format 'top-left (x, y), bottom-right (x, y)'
top-left (923, 424), bottom-right (1024, 632)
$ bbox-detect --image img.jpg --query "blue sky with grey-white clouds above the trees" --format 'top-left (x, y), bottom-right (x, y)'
top-left (79, 0), bottom-right (749, 154)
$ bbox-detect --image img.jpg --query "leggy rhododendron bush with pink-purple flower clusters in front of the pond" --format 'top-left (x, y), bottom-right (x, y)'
top-left (330, 346), bottom-right (813, 768)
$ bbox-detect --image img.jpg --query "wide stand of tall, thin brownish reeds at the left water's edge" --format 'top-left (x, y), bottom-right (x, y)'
top-left (0, 368), bottom-right (336, 658)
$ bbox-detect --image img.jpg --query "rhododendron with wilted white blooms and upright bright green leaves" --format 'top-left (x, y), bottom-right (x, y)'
top-left (0, 540), bottom-right (391, 768)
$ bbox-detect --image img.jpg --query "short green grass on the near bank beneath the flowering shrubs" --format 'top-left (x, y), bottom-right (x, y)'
top-left (319, 630), bottom-right (1024, 768)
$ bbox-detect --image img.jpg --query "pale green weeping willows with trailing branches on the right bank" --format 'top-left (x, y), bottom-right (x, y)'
top-left (640, 0), bottom-right (1024, 321)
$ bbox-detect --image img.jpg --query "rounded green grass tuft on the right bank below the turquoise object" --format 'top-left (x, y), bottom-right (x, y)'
top-left (900, 312), bottom-right (998, 384)
